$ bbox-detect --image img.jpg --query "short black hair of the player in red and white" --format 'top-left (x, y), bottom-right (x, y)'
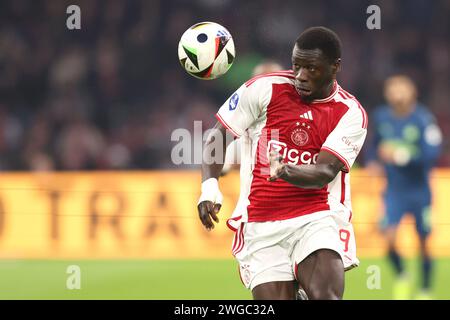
top-left (295, 27), bottom-right (341, 62)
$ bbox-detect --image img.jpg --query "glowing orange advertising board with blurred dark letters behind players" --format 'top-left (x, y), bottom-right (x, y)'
top-left (0, 170), bottom-right (450, 259)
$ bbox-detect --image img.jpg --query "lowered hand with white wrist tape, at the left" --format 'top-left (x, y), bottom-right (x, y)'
top-left (197, 178), bottom-right (223, 231)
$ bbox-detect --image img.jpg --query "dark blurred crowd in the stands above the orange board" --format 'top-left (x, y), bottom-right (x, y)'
top-left (0, 0), bottom-right (450, 171)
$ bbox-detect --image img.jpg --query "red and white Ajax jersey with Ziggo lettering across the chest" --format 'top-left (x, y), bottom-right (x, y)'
top-left (216, 71), bottom-right (367, 227)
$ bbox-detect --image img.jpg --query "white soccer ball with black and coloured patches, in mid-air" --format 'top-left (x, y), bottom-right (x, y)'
top-left (178, 22), bottom-right (235, 80)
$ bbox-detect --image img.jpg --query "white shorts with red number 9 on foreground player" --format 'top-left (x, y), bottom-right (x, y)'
top-left (233, 211), bottom-right (359, 290)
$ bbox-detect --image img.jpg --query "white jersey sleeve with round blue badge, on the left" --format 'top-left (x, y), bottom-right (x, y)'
top-left (216, 78), bottom-right (272, 137)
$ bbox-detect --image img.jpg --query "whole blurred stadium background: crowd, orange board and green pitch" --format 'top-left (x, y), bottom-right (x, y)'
top-left (0, 0), bottom-right (450, 299)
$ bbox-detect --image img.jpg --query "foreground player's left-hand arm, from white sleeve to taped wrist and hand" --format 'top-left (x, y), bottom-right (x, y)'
top-left (197, 79), bottom-right (272, 230)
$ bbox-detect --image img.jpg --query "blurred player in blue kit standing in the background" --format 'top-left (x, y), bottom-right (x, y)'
top-left (368, 75), bottom-right (442, 299)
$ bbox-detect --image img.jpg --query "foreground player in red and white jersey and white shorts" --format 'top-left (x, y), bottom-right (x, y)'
top-left (198, 27), bottom-right (367, 299)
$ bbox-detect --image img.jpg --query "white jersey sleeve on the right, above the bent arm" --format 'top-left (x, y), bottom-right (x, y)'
top-left (321, 108), bottom-right (367, 172)
